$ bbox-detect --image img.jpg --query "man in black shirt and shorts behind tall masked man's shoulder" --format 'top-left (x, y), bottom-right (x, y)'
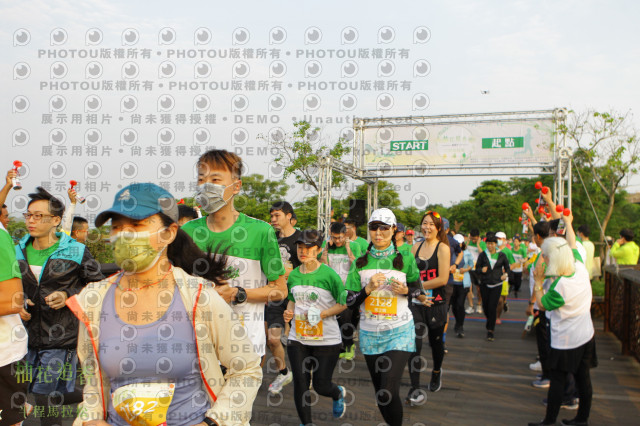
top-left (265, 201), bottom-right (302, 394)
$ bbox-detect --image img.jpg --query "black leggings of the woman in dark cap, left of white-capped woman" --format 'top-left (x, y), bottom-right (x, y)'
top-left (287, 340), bottom-right (342, 425)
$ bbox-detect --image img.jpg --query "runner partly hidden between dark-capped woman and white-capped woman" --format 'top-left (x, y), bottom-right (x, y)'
top-left (320, 222), bottom-right (362, 361)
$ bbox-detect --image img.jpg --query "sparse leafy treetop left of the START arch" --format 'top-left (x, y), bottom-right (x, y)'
top-left (266, 121), bottom-right (351, 192)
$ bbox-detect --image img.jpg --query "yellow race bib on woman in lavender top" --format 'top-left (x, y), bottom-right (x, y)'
top-left (111, 383), bottom-right (176, 426)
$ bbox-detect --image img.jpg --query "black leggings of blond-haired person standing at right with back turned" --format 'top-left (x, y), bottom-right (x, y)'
top-left (544, 361), bottom-right (593, 422)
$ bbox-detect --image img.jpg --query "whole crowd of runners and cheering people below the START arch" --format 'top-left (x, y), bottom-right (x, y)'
top-left (0, 150), bottom-right (638, 426)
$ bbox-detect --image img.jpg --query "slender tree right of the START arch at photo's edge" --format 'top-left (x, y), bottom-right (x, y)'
top-left (559, 109), bottom-right (640, 254)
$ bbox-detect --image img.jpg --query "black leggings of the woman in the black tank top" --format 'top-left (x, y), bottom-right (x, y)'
top-left (407, 303), bottom-right (446, 389)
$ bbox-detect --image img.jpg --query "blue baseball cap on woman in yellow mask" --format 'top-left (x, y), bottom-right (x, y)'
top-left (96, 183), bottom-right (179, 227)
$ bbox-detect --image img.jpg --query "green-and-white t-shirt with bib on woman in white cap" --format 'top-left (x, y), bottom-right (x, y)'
top-left (346, 252), bottom-right (420, 332)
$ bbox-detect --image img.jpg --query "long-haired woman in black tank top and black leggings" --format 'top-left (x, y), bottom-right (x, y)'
top-left (405, 211), bottom-right (451, 405)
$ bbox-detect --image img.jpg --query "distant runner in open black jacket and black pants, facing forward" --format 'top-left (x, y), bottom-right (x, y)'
top-left (475, 232), bottom-right (510, 342)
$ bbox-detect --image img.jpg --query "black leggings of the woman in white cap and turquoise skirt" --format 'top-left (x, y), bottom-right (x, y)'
top-left (364, 351), bottom-right (410, 426)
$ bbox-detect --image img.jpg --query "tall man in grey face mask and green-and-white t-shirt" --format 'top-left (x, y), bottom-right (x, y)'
top-left (182, 149), bottom-right (287, 356)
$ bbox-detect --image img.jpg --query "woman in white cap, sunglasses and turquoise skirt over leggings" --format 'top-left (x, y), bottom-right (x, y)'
top-left (346, 208), bottom-right (420, 426)
